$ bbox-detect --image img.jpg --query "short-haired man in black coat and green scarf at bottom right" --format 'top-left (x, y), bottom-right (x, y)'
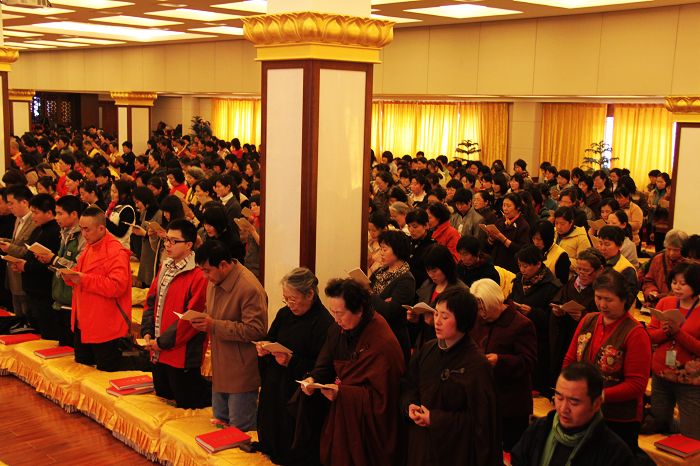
top-left (511, 362), bottom-right (636, 466)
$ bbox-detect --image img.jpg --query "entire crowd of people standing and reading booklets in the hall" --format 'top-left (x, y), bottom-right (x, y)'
top-left (0, 127), bottom-right (700, 466)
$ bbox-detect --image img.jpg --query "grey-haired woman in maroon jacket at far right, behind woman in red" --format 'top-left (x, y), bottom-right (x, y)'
top-left (642, 229), bottom-right (688, 305)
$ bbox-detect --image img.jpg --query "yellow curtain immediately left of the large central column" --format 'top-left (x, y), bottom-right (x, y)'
top-left (211, 99), bottom-right (262, 145)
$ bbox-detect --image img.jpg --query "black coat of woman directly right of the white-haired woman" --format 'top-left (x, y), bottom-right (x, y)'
top-left (509, 264), bottom-right (561, 394)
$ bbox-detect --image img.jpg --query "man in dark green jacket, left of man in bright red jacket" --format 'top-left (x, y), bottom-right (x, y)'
top-left (35, 195), bottom-right (85, 346)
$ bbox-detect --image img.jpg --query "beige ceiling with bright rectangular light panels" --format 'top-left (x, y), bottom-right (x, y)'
top-left (2, 0), bottom-right (697, 51)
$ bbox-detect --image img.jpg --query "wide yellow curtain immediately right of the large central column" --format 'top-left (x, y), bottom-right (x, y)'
top-left (371, 101), bottom-right (509, 164)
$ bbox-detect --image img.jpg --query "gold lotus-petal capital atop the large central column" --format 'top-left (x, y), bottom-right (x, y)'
top-left (241, 11), bottom-right (394, 63)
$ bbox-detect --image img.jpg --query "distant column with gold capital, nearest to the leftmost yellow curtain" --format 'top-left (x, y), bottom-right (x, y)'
top-left (110, 91), bottom-right (158, 155)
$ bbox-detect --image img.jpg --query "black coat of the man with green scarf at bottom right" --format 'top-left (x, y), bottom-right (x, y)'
top-left (510, 411), bottom-right (636, 466)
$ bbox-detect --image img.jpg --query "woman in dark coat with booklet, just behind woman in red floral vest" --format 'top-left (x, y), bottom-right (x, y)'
top-left (549, 248), bottom-right (605, 379)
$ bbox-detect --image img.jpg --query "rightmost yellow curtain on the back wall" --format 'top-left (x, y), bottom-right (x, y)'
top-left (612, 104), bottom-right (673, 189)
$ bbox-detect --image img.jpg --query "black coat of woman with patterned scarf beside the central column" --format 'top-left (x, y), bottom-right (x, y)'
top-left (370, 272), bottom-right (416, 361)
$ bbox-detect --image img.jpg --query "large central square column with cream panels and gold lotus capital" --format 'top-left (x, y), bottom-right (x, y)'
top-left (243, 12), bottom-right (393, 318)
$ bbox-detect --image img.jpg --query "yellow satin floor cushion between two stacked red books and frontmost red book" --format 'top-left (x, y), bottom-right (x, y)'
top-left (113, 394), bottom-right (207, 460)
